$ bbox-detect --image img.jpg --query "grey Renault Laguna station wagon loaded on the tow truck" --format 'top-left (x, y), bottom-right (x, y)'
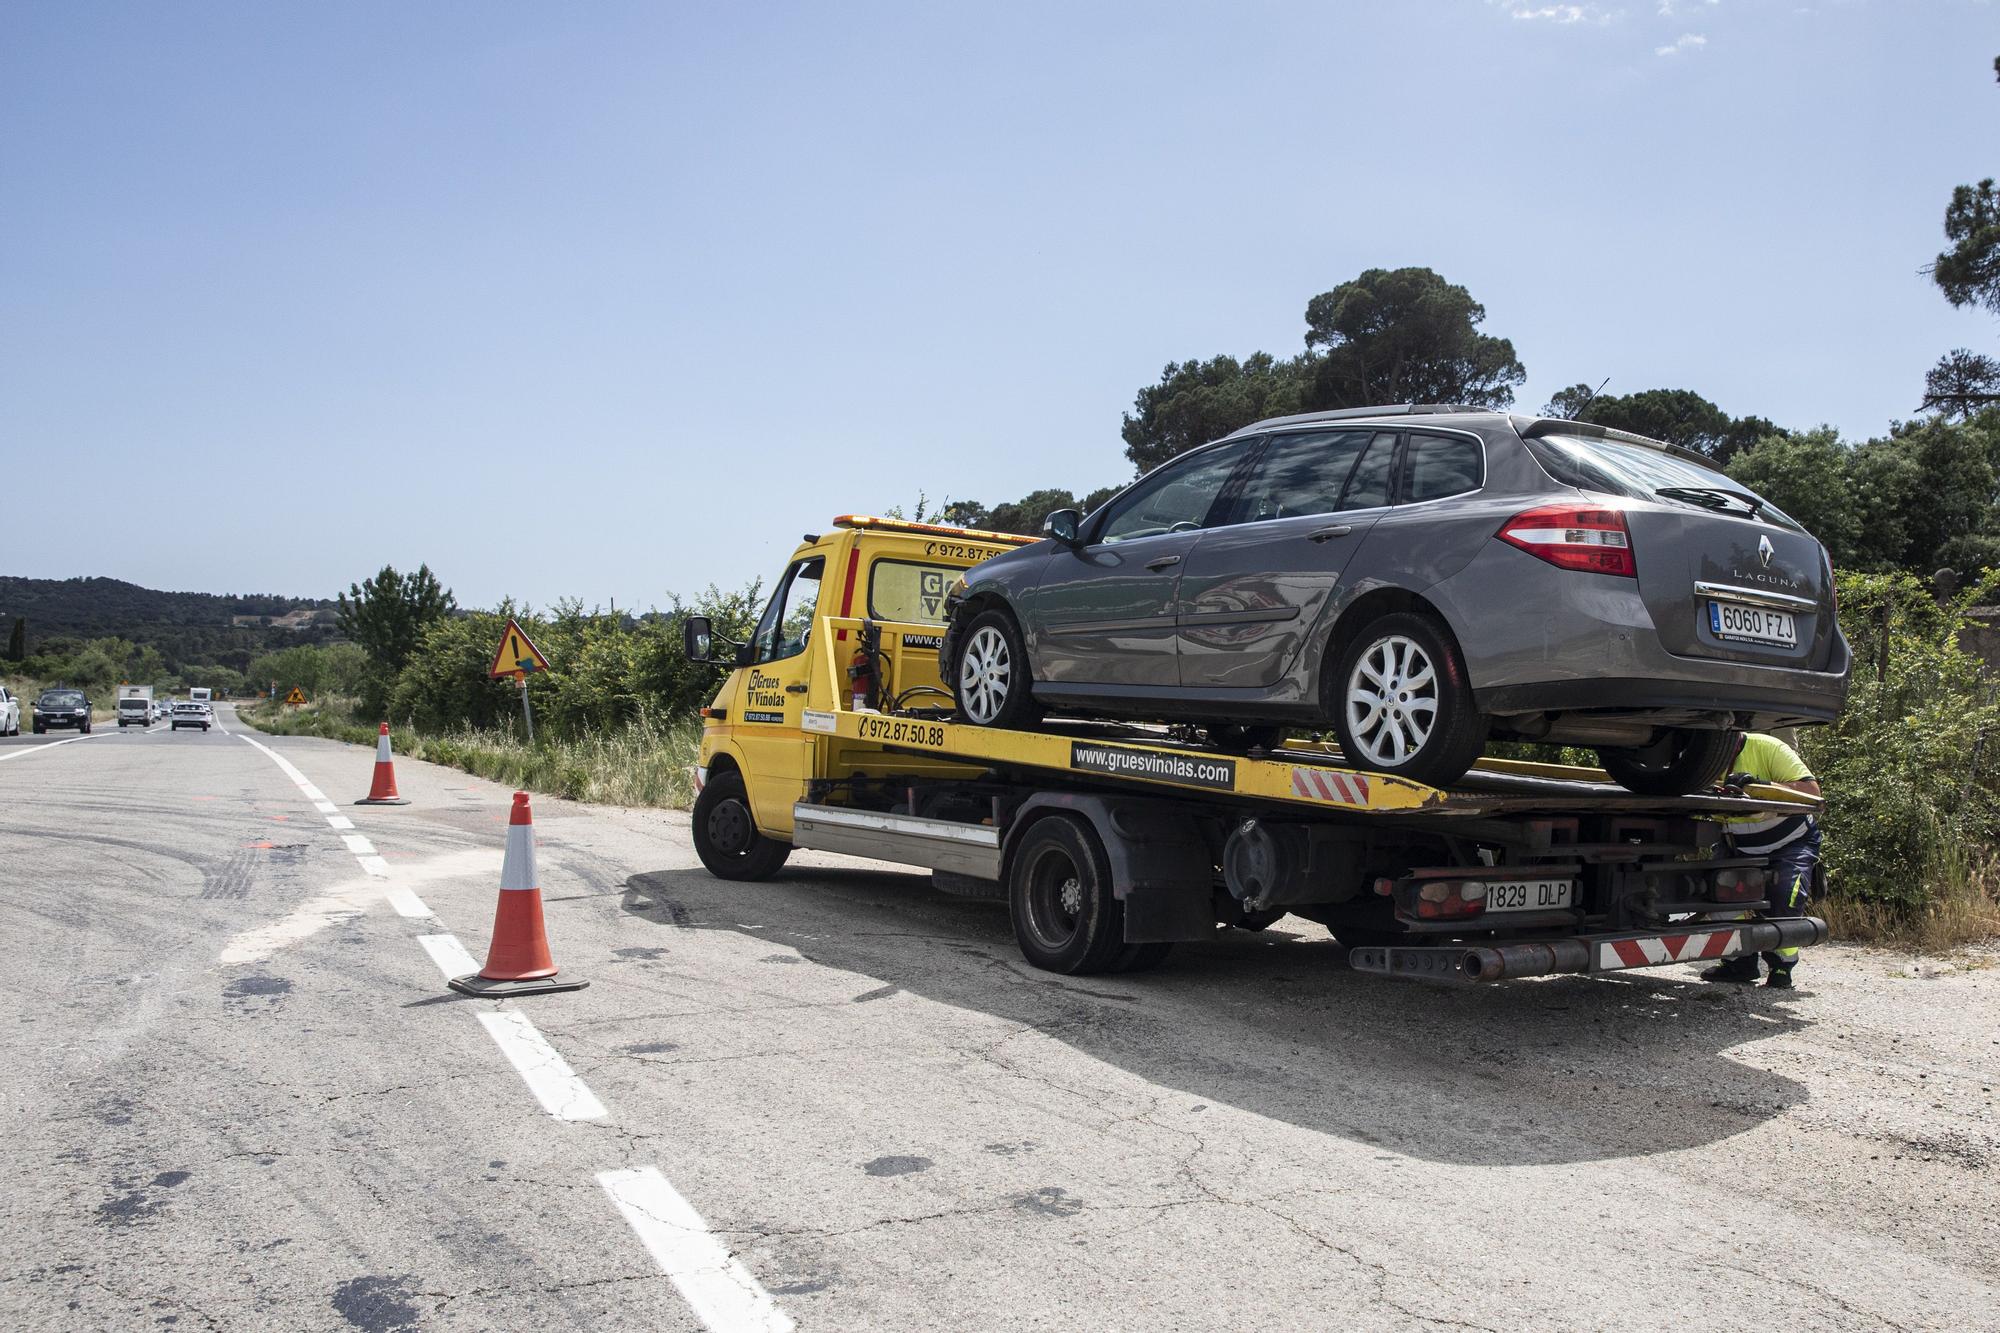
top-left (944, 406), bottom-right (1850, 795)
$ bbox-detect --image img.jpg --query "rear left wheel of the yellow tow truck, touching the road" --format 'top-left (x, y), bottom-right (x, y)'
top-left (1008, 815), bottom-right (1126, 964)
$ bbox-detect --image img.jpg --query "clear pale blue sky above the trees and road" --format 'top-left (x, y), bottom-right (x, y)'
top-left (0, 0), bottom-right (2000, 610)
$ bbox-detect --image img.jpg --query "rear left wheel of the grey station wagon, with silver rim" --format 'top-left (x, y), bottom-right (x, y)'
top-left (1326, 610), bottom-right (1488, 787)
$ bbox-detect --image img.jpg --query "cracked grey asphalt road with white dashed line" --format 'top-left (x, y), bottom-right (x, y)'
top-left (0, 709), bottom-right (2000, 1333)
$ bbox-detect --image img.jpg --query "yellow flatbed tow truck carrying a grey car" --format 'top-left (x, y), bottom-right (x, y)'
top-left (684, 514), bottom-right (1826, 981)
